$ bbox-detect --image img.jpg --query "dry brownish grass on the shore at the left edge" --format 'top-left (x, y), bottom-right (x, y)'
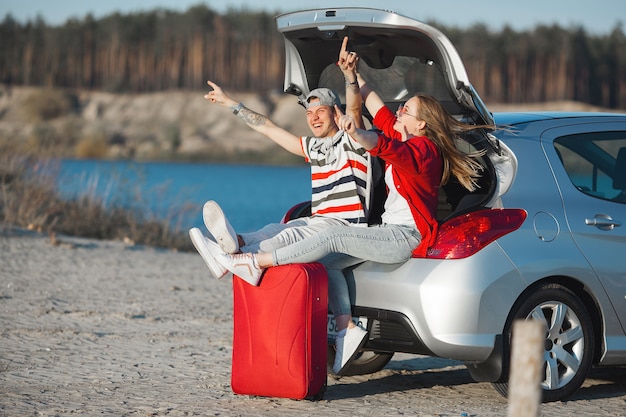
top-left (0, 146), bottom-right (193, 251)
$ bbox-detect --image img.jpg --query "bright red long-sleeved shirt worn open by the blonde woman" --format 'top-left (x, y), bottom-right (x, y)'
top-left (370, 107), bottom-right (443, 257)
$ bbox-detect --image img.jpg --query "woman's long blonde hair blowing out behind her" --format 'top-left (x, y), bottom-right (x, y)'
top-left (415, 94), bottom-right (494, 191)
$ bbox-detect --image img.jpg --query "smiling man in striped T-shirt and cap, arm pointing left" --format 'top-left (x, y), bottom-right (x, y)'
top-left (189, 81), bottom-right (373, 286)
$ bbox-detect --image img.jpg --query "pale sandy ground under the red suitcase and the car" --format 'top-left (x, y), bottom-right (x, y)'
top-left (0, 226), bottom-right (626, 417)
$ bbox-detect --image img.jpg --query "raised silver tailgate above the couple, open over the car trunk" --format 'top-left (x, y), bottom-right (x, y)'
top-left (276, 8), bottom-right (493, 124)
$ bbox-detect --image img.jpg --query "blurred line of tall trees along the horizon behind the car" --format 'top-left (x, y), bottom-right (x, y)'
top-left (0, 5), bottom-right (626, 109)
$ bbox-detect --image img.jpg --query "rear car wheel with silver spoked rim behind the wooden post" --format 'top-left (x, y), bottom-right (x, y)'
top-left (493, 284), bottom-right (594, 402)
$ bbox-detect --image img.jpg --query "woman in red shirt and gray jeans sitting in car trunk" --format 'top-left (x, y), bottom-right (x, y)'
top-left (217, 96), bottom-right (446, 277)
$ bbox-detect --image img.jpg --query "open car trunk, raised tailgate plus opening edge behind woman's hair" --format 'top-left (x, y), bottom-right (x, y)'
top-left (276, 8), bottom-right (515, 221)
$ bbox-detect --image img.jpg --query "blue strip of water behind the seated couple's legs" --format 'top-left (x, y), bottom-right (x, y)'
top-left (57, 160), bottom-right (311, 232)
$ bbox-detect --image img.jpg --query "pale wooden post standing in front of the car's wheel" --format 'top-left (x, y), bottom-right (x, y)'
top-left (508, 320), bottom-right (545, 417)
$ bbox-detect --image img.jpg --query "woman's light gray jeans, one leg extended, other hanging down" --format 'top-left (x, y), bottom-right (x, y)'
top-left (272, 224), bottom-right (421, 317)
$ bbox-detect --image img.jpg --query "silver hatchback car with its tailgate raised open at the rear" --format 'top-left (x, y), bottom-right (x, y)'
top-left (276, 8), bottom-right (626, 401)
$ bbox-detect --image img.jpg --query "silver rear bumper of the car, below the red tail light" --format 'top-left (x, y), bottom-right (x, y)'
top-left (353, 242), bottom-right (525, 362)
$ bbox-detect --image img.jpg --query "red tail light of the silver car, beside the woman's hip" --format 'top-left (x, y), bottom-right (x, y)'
top-left (426, 209), bottom-right (526, 259)
